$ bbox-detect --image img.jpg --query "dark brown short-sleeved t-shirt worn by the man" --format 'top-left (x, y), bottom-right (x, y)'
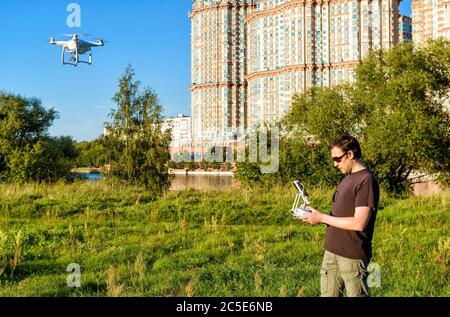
top-left (325, 170), bottom-right (380, 261)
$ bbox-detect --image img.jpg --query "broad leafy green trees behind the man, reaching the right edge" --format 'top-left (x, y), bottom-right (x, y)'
top-left (287, 40), bottom-right (450, 193)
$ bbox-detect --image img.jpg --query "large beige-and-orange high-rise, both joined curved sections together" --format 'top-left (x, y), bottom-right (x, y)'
top-left (190, 0), bottom-right (400, 146)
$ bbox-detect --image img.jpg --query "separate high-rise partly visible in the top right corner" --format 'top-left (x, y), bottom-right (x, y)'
top-left (412, 0), bottom-right (450, 45)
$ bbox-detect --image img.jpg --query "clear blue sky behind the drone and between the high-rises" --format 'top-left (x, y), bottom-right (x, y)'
top-left (0, 0), bottom-right (411, 141)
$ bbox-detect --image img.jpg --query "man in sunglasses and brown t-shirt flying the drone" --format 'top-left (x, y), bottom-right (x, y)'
top-left (300, 136), bottom-right (380, 297)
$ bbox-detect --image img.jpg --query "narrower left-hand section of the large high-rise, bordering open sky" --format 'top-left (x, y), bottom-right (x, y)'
top-left (190, 0), bottom-right (254, 155)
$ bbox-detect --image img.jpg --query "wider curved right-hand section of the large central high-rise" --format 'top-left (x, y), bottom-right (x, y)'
top-left (246, 0), bottom-right (399, 128)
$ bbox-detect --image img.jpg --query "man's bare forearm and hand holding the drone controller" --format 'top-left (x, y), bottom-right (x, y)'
top-left (300, 207), bottom-right (373, 232)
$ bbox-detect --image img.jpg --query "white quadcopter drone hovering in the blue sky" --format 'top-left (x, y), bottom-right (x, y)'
top-left (50, 34), bottom-right (105, 67)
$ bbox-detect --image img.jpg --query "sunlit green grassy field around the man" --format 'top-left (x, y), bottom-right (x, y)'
top-left (0, 182), bottom-right (450, 296)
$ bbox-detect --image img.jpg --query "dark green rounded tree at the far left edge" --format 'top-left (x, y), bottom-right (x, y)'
top-left (0, 93), bottom-right (77, 183)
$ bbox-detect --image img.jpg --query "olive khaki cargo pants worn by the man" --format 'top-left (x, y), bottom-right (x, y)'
top-left (320, 251), bottom-right (369, 297)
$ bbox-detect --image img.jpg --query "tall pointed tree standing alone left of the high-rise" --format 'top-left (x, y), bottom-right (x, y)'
top-left (104, 65), bottom-right (171, 192)
